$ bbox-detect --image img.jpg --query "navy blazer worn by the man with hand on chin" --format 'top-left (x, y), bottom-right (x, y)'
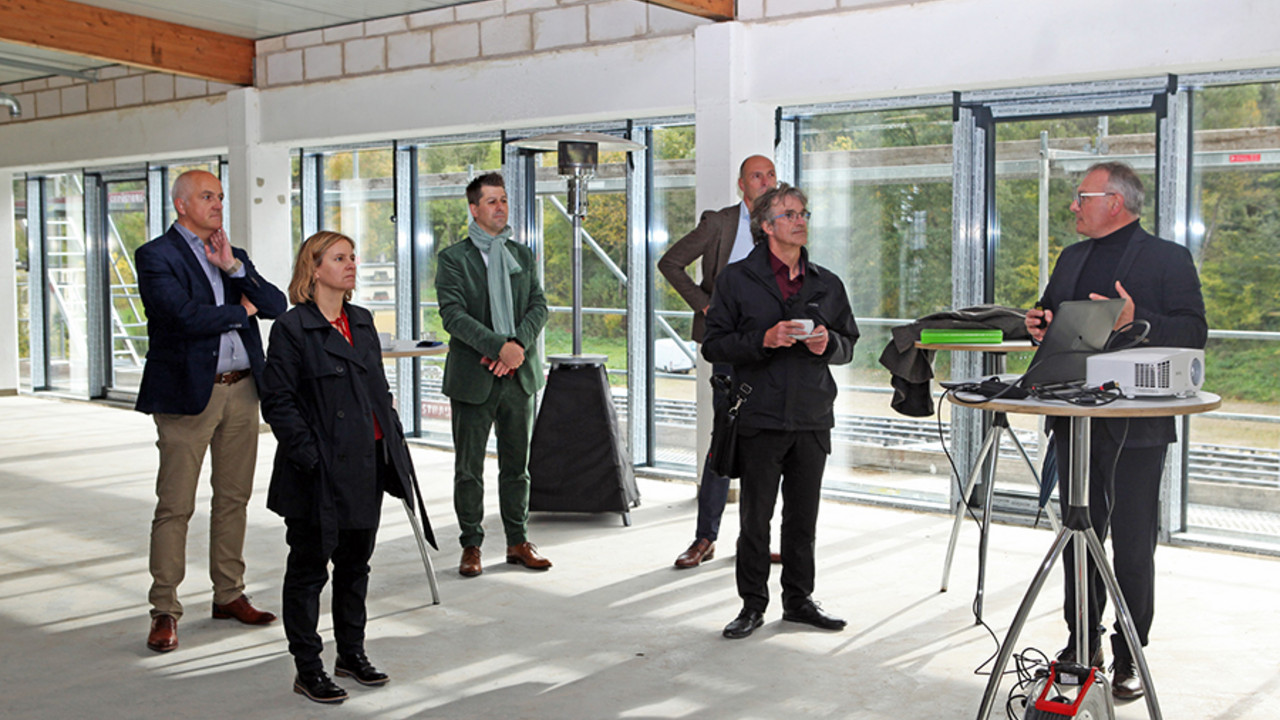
top-left (133, 227), bottom-right (288, 415)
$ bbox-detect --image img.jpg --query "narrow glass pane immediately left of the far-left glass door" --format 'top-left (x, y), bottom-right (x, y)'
top-left (44, 173), bottom-right (88, 396)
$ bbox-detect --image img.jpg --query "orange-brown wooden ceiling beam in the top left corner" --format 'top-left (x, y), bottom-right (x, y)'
top-left (0, 0), bottom-right (253, 85)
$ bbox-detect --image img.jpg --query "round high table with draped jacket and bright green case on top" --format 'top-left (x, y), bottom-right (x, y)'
top-left (915, 341), bottom-right (1062, 624)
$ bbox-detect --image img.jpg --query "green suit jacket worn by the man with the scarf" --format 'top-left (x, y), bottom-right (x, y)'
top-left (435, 238), bottom-right (547, 405)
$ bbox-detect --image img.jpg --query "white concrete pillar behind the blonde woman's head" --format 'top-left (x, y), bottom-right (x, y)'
top-left (227, 87), bottom-right (293, 299)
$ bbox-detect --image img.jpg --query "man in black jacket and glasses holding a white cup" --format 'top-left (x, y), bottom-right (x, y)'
top-left (703, 184), bottom-right (859, 638)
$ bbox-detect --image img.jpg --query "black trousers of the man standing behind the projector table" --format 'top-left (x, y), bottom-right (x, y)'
top-left (1053, 424), bottom-right (1169, 657)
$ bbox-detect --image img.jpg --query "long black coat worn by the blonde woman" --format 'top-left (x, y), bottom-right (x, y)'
top-left (261, 302), bottom-right (435, 547)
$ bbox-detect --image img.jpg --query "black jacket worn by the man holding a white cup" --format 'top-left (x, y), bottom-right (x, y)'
top-left (703, 242), bottom-right (859, 430)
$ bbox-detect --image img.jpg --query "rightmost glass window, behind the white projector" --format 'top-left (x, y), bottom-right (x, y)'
top-left (1187, 82), bottom-right (1280, 543)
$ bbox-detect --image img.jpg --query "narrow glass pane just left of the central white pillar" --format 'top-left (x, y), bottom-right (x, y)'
top-left (650, 126), bottom-right (701, 471)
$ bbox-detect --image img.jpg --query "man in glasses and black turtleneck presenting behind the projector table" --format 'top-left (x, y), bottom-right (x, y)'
top-left (1027, 163), bottom-right (1208, 700)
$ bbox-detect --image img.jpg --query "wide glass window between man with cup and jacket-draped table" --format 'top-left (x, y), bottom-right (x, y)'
top-left (799, 106), bottom-right (952, 502)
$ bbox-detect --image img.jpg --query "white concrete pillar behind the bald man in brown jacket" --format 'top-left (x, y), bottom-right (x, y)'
top-left (694, 23), bottom-right (774, 489)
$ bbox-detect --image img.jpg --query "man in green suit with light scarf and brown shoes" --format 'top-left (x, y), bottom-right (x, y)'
top-left (435, 173), bottom-right (552, 578)
